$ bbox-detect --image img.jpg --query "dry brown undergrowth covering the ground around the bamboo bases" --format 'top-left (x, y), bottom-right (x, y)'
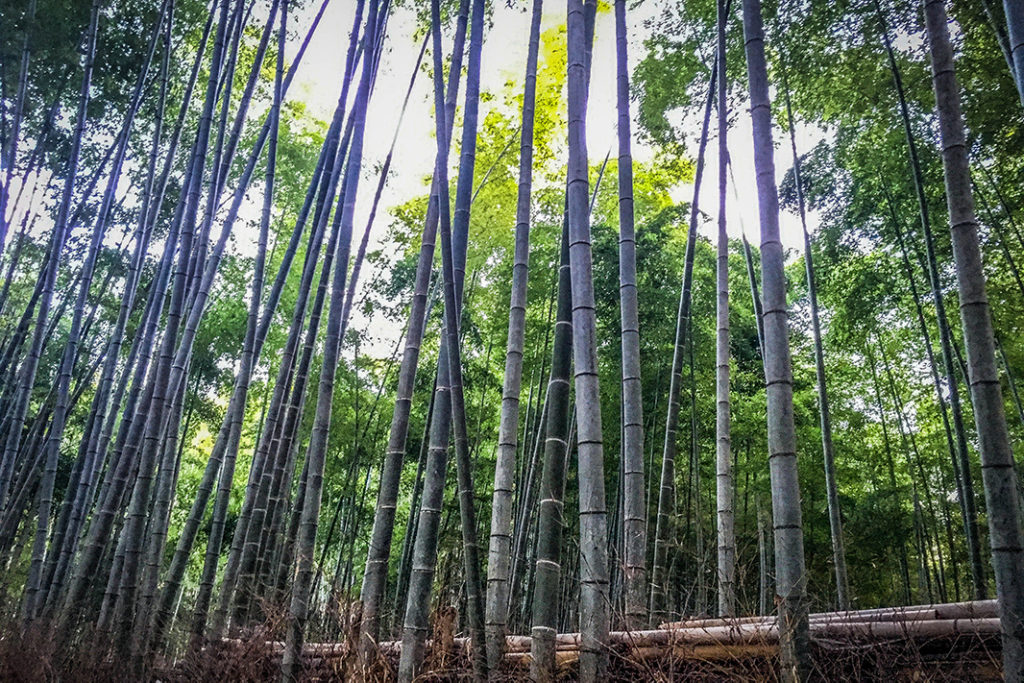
top-left (0, 605), bottom-right (1001, 683)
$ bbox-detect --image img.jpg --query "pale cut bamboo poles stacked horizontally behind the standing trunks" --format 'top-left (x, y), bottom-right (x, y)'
top-left (234, 600), bottom-right (999, 666)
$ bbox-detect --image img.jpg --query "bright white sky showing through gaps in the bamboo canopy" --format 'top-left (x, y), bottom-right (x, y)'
top-left (289, 0), bottom-right (821, 352)
